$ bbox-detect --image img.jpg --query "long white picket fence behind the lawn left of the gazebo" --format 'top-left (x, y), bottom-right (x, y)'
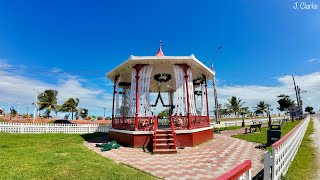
top-left (0, 122), bottom-right (111, 134)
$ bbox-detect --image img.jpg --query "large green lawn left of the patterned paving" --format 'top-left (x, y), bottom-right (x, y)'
top-left (0, 133), bottom-right (155, 179)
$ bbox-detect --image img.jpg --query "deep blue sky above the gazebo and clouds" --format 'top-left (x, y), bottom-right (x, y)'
top-left (0, 0), bottom-right (320, 114)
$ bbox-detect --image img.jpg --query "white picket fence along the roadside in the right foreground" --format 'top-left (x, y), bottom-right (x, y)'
top-left (264, 116), bottom-right (310, 180)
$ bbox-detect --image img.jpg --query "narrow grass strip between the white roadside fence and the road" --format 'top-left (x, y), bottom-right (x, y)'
top-left (285, 120), bottom-right (318, 180)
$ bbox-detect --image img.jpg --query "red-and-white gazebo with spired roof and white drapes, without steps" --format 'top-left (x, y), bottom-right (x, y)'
top-left (107, 42), bottom-right (215, 150)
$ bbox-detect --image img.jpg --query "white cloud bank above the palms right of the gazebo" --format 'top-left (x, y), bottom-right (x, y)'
top-left (209, 72), bottom-right (320, 113)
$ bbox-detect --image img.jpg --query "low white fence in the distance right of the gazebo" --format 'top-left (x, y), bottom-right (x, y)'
top-left (210, 117), bottom-right (290, 128)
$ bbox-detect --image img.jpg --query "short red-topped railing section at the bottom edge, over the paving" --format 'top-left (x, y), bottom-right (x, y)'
top-left (215, 160), bottom-right (252, 180)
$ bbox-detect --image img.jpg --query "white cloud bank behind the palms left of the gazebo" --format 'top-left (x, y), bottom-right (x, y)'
top-left (0, 71), bottom-right (112, 115)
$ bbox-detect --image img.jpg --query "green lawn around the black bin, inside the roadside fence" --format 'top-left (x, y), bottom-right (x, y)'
top-left (232, 121), bottom-right (300, 150)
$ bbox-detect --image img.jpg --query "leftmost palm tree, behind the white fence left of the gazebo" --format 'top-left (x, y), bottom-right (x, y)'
top-left (38, 89), bottom-right (59, 118)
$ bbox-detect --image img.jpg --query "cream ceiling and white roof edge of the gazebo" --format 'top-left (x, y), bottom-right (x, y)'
top-left (107, 55), bottom-right (215, 92)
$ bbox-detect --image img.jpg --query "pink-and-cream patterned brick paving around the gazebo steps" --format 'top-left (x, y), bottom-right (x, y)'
top-left (84, 130), bottom-right (264, 179)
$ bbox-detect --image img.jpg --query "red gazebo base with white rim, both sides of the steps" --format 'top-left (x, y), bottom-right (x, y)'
top-left (109, 127), bottom-right (213, 147)
